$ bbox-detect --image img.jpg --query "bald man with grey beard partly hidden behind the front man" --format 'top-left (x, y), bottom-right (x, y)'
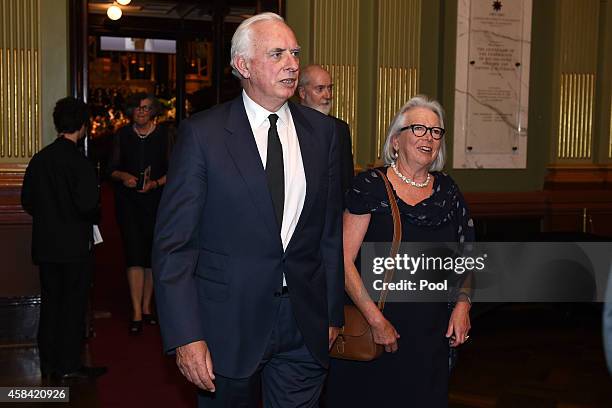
top-left (298, 64), bottom-right (354, 194)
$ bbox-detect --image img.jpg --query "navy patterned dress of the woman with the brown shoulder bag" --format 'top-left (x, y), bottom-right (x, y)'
top-left (324, 168), bottom-right (474, 408)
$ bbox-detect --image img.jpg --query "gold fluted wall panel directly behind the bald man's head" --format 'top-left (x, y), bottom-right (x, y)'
top-left (311, 0), bottom-right (360, 156)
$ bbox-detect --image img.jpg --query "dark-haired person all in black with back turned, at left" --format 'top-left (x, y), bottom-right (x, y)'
top-left (21, 97), bottom-right (105, 379)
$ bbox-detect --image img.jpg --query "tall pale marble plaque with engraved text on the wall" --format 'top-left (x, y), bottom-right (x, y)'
top-left (453, 0), bottom-right (532, 169)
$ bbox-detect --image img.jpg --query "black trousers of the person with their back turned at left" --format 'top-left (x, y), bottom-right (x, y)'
top-left (38, 259), bottom-right (93, 375)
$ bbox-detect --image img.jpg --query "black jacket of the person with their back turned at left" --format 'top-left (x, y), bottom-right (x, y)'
top-left (21, 138), bottom-right (99, 264)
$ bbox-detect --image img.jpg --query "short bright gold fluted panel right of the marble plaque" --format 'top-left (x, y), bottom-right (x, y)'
top-left (557, 73), bottom-right (595, 159)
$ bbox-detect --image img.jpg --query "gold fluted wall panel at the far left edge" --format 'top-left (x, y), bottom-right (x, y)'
top-left (0, 0), bottom-right (41, 163)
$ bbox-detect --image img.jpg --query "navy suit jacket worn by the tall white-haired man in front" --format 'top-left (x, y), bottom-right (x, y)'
top-left (153, 97), bottom-right (344, 378)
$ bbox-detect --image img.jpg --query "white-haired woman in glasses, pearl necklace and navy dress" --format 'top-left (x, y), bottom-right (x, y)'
top-left (325, 96), bottom-right (474, 408)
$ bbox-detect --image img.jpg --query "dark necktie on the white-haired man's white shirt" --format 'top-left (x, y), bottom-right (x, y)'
top-left (266, 113), bottom-right (285, 231)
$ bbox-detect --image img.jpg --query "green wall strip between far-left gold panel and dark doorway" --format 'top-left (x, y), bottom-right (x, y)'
top-left (40, 0), bottom-right (70, 146)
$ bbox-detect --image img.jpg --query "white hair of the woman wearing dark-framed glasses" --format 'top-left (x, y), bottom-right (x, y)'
top-left (382, 95), bottom-right (446, 171)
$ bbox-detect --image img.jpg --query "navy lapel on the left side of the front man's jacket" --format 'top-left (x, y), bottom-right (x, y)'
top-left (225, 95), bottom-right (282, 245)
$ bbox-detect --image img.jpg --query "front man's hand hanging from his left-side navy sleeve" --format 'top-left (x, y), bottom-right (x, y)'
top-left (176, 340), bottom-right (215, 392)
